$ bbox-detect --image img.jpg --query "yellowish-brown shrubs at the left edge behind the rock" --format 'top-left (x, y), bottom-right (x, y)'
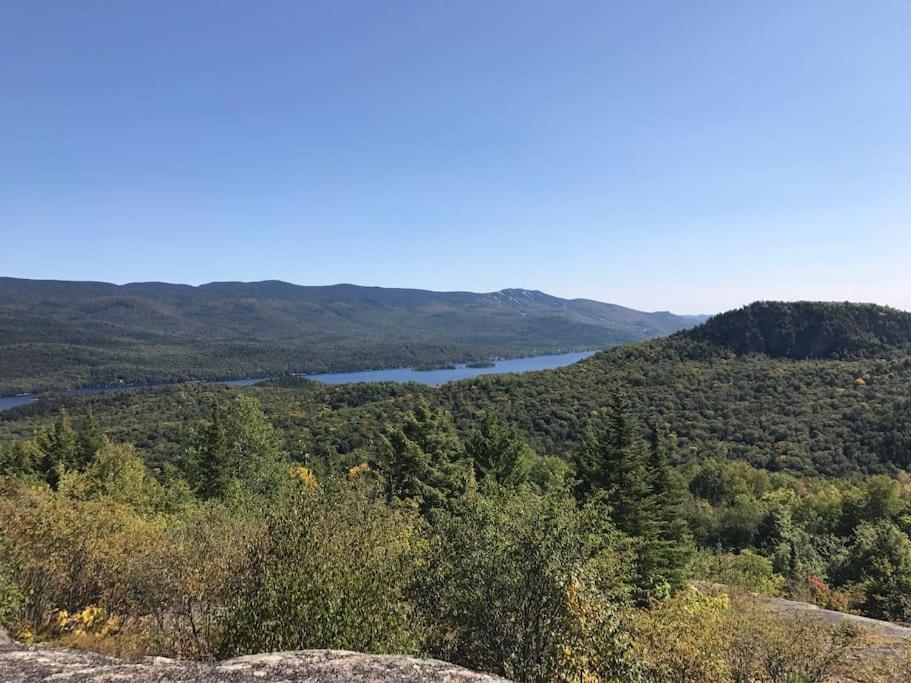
top-left (0, 477), bottom-right (258, 657)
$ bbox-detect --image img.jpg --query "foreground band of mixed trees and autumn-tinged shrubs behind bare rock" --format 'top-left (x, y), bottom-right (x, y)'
top-left (0, 395), bottom-right (911, 683)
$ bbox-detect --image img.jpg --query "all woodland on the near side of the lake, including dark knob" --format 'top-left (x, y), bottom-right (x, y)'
top-left (0, 304), bottom-right (911, 683)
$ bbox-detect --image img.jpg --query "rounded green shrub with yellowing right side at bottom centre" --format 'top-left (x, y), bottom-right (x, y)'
top-left (417, 487), bottom-right (631, 681)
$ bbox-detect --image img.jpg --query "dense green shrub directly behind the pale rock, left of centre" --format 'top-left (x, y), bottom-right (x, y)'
top-left (219, 478), bottom-right (425, 656)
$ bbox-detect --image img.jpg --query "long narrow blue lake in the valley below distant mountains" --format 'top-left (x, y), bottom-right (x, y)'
top-left (0, 351), bottom-right (595, 412)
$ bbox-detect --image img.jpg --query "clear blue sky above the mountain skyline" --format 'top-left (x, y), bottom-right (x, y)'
top-left (0, 0), bottom-right (911, 313)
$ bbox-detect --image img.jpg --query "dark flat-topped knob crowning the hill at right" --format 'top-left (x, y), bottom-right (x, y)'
top-left (681, 301), bottom-right (911, 358)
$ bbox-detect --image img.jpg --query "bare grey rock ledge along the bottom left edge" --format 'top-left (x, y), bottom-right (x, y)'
top-left (0, 629), bottom-right (503, 683)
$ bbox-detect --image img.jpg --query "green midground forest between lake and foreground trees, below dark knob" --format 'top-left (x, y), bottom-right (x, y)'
top-left (0, 304), bottom-right (911, 475)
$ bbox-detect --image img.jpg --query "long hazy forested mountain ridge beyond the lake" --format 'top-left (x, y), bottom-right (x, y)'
top-left (0, 278), bottom-right (698, 394)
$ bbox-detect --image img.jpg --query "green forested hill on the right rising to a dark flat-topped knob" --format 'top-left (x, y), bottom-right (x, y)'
top-left (441, 304), bottom-right (911, 474)
